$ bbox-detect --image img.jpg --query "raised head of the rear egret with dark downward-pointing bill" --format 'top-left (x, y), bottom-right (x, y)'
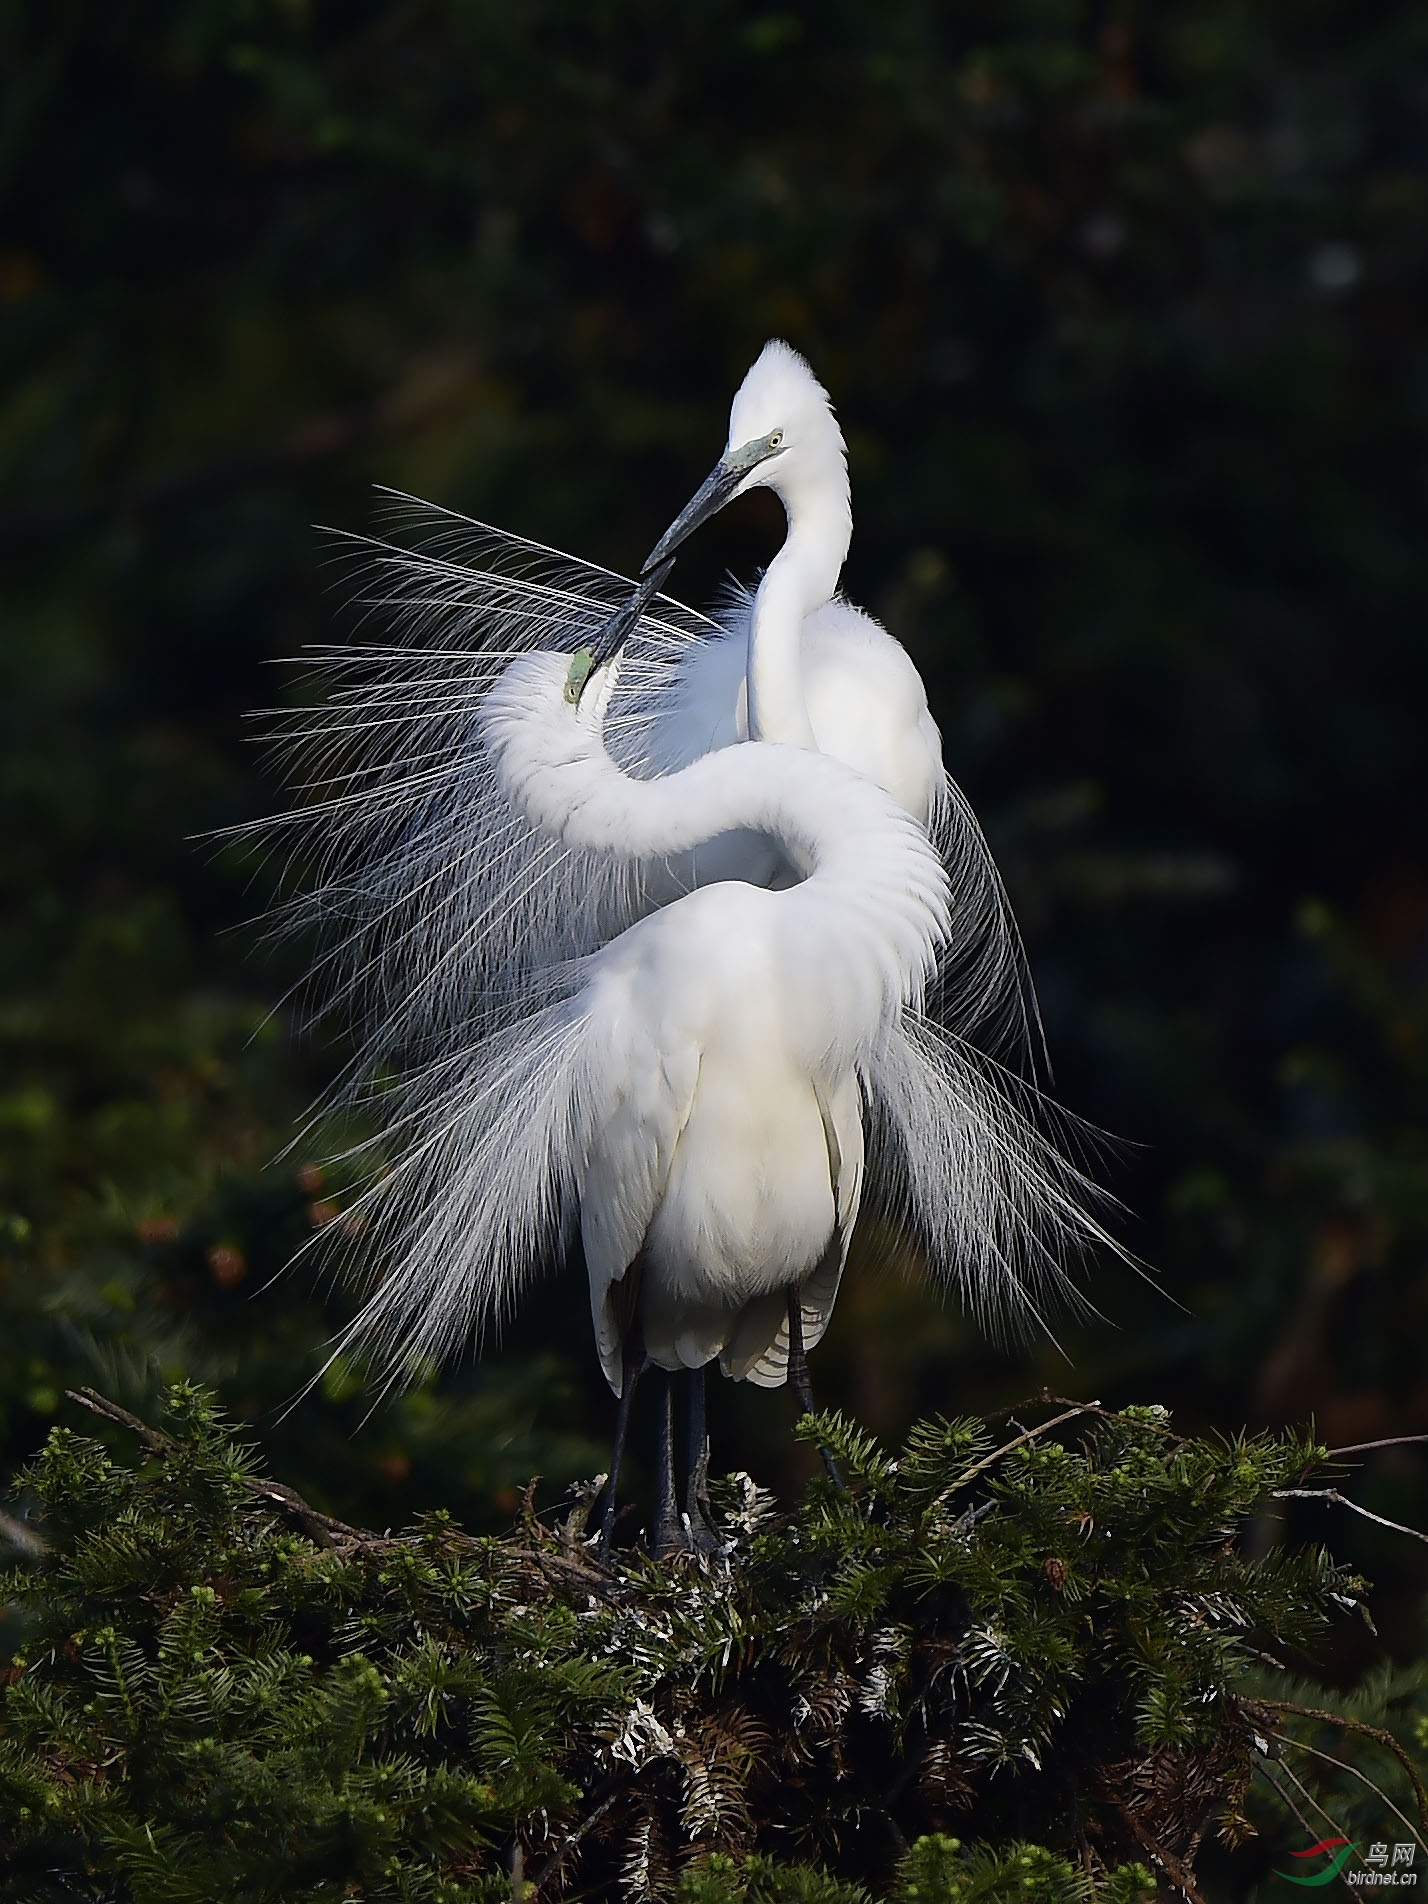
top-left (645, 337), bottom-right (847, 571)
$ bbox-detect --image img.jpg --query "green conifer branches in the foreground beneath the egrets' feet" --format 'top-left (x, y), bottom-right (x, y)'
top-left (0, 1384), bottom-right (1428, 1904)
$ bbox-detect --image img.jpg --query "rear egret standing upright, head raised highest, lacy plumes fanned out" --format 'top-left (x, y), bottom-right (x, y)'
top-left (257, 343), bottom-right (1032, 1068)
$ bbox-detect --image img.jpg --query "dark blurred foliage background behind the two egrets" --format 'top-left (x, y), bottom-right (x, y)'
top-left (0, 0), bottom-right (1428, 1645)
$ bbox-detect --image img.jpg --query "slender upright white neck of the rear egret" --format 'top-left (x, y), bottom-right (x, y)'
top-left (748, 459), bottom-right (853, 750)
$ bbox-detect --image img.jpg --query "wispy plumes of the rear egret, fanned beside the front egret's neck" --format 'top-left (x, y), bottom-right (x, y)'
top-left (249, 497), bottom-right (1032, 1076)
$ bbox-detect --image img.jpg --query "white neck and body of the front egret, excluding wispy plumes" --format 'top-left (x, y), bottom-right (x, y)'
top-left (482, 655), bottom-right (948, 1390)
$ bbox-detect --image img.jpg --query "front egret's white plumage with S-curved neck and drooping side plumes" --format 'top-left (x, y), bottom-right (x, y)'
top-left (327, 655), bottom-right (1114, 1390)
